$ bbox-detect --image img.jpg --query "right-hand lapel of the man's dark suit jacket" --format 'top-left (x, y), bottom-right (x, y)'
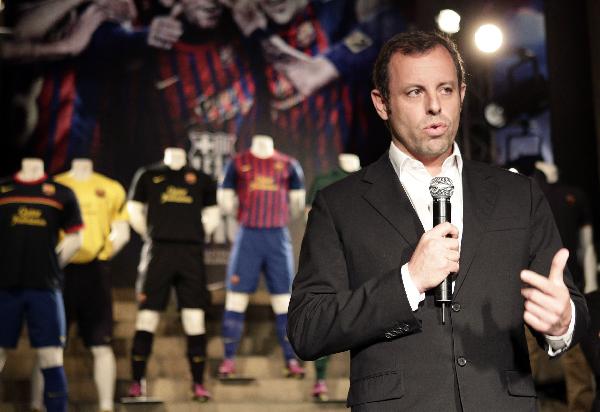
top-left (454, 161), bottom-right (497, 296)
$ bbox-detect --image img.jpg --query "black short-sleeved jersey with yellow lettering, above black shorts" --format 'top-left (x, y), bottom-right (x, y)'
top-left (129, 163), bottom-right (217, 243)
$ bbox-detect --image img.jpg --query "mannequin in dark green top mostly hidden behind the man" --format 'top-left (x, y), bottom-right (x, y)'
top-left (305, 153), bottom-right (360, 402)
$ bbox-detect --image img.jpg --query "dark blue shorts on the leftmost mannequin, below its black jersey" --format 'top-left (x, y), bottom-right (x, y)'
top-left (0, 289), bottom-right (66, 348)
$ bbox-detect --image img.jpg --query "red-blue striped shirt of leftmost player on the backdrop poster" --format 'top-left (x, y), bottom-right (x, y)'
top-left (32, 22), bottom-right (147, 174)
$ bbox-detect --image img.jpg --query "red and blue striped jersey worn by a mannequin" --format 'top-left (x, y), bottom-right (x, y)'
top-left (221, 150), bottom-right (304, 229)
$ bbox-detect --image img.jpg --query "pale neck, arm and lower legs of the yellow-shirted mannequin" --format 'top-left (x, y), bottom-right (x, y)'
top-left (31, 158), bottom-right (129, 411)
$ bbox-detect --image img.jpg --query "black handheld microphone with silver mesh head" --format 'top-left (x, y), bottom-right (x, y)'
top-left (429, 177), bottom-right (454, 324)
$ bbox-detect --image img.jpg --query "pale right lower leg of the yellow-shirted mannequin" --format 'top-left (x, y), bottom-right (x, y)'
top-left (90, 345), bottom-right (117, 411)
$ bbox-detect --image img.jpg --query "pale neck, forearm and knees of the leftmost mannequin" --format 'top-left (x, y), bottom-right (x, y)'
top-left (0, 158), bottom-right (83, 412)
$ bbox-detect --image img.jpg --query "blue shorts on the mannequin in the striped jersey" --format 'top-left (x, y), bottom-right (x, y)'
top-left (227, 226), bottom-right (294, 295)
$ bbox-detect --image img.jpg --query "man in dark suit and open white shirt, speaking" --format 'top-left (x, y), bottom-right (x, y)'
top-left (288, 32), bottom-right (588, 412)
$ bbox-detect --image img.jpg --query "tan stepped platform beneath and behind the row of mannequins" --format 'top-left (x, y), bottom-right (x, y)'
top-left (0, 288), bottom-right (349, 412)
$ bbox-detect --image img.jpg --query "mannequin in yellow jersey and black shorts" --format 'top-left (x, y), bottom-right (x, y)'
top-left (31, 158), bottom-right (129, 411)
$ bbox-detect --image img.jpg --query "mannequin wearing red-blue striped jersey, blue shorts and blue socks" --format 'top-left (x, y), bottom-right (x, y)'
top-left (217, 134), bottom-right (306, 378)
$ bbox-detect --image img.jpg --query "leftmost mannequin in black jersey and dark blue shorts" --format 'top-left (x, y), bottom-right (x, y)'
top-left (0, 158), bottom-right (83, 412)
